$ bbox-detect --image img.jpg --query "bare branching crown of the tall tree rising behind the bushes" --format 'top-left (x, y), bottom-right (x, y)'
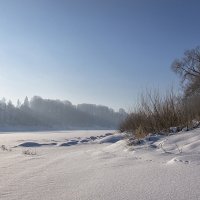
top-left (172, 46), bottom-right (200, 96)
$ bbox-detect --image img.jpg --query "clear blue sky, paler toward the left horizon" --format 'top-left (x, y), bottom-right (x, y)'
top-left (0, 0), bottom-right (200, 109)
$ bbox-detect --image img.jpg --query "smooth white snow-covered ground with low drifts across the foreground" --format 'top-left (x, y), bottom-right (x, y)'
top-left (0, 129), bottom-right (200, 200)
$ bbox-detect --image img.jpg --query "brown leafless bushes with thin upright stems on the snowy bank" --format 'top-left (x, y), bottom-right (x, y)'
top-left (120, 89), bottom-right (200, 138)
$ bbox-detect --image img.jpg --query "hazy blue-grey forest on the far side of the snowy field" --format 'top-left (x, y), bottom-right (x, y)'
top-left (0, 96), bottom-right (127, 130)
